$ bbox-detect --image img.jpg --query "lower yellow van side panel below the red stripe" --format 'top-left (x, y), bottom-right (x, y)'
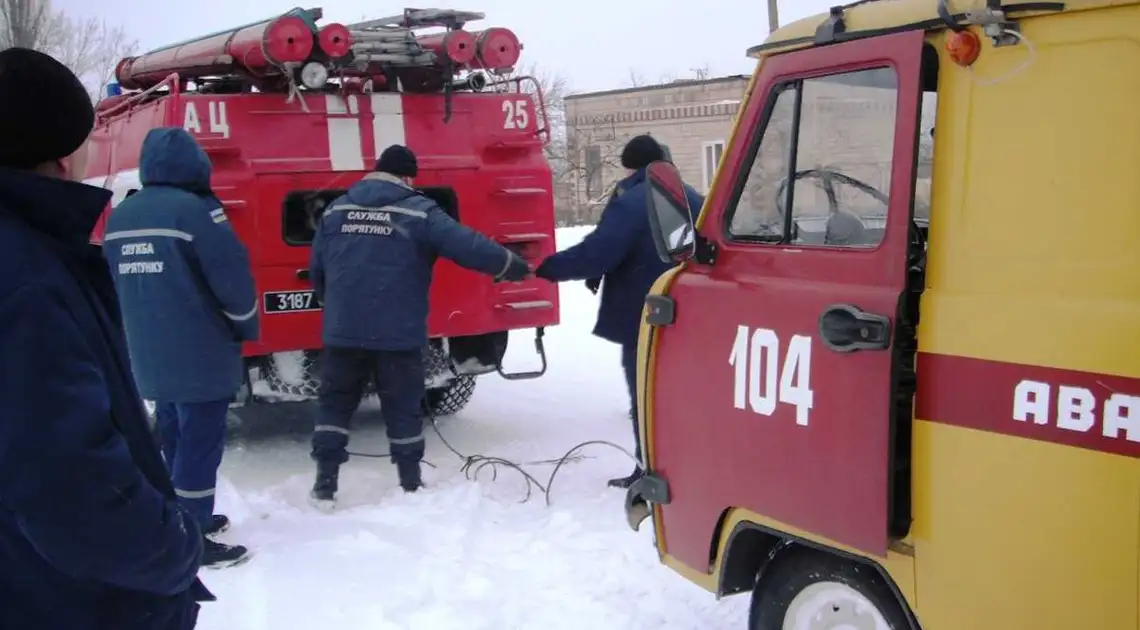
top-left (912, 422), bottom-right (1140, 630)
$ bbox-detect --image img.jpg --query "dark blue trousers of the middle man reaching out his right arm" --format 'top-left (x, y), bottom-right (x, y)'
top-left (312, 346), bottom-right (424, 464)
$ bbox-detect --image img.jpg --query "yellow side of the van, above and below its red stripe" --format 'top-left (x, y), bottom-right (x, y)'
top-left (912, 11), bottom-right (1140, 630)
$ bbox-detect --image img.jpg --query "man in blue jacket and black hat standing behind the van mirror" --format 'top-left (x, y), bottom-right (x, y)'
top-left (535, 134), bottom-right (705, 488)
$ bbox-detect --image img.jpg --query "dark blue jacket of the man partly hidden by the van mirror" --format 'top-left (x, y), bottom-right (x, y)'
top-left (540, 169), bottom-right (705, 345)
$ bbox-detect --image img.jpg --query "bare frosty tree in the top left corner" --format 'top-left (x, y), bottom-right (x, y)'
top-left (0, 0), bottom-right (137, 93)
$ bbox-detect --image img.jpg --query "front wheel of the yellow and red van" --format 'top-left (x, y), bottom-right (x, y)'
top-left (748, 547), bottom-right (911, 630)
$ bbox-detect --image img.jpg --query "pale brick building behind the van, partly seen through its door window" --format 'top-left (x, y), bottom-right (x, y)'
top-left (559, 69), bottom-right (936, 229)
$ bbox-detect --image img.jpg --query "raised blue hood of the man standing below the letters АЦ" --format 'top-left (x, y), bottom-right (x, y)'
top-left (139, 126), bottom-right (211, 194)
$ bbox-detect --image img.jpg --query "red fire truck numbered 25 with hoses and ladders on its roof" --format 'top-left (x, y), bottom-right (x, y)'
top-left (86, 8), bottom-right (559, 414)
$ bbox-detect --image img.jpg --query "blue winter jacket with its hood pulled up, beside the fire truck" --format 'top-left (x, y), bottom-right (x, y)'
top-left (104, 128), bottom-right (259, 402)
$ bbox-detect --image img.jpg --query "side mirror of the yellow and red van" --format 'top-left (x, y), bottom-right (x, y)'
top-left (645, 162), bottom-right (697, 263)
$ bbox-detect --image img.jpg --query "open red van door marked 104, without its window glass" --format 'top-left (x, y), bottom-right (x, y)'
top-left (651, 31), bottom-right (923, 562)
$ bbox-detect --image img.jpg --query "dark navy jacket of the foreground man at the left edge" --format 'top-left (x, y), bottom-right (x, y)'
top-left (0, 164), bottom-right (212, 630)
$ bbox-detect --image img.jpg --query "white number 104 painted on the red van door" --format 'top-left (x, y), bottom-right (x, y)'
top-left (728, 326), bottom-right (815, 426)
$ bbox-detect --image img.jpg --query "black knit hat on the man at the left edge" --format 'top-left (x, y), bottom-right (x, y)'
top-left (0, 48), bottom-right (95, 169)
